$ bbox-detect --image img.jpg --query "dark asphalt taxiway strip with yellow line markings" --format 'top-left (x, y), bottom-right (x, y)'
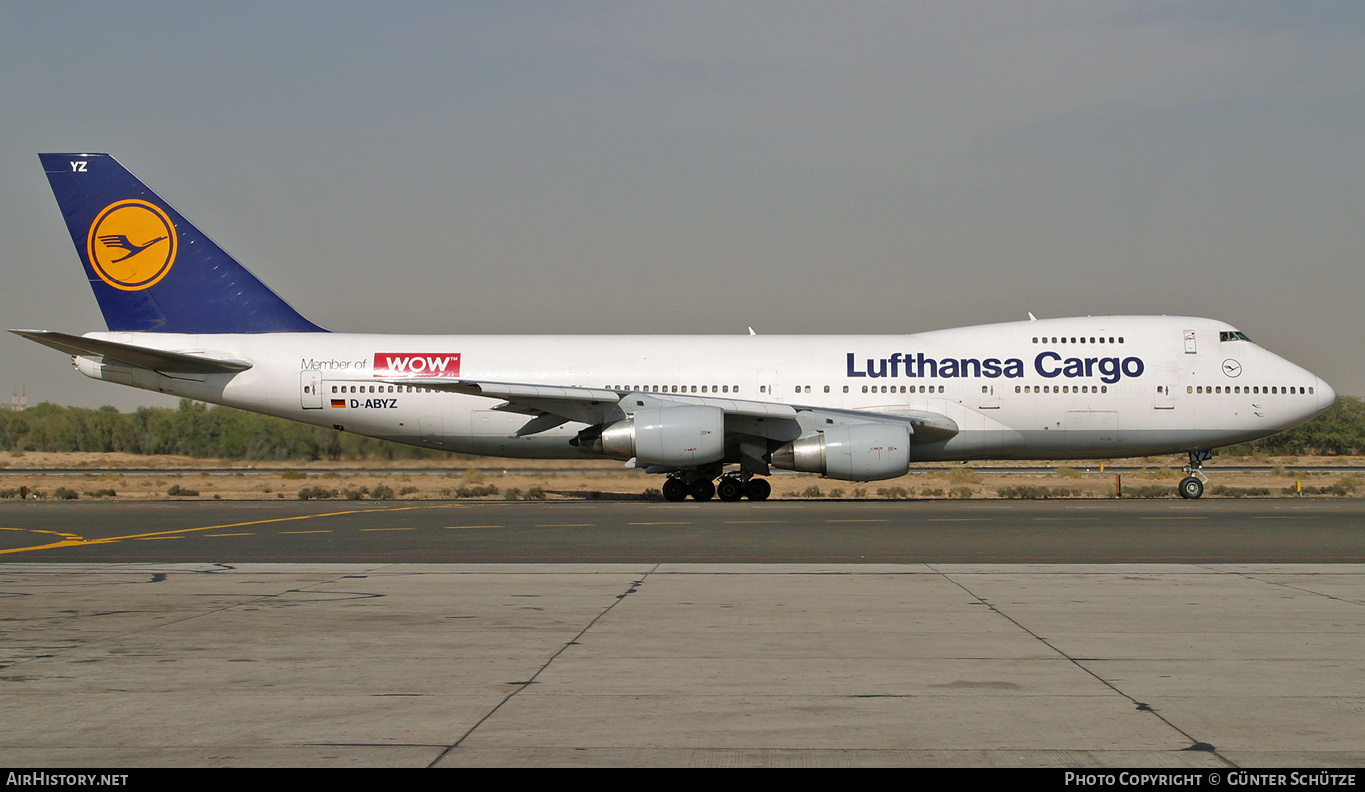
top-left (0, 498), bottom-right (1365, 564)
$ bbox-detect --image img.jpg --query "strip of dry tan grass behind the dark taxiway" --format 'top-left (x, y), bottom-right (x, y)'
top-left (0, 453), bottom-right (1365, 500)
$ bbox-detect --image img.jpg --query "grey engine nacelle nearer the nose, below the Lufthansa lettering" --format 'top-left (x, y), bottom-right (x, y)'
top-left (773, 423), bottom-right (910, 481)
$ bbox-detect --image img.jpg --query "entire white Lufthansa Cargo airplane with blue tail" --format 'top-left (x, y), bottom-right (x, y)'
top-left (12, 154), bottom-right (1336, 501)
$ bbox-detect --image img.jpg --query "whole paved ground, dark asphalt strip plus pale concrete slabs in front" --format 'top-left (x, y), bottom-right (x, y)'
top-left (0, 500), bottom-right (1365, 764)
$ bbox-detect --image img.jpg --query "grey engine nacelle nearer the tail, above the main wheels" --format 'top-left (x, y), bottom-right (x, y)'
top-left (573, 404), bottom-right (725, 466)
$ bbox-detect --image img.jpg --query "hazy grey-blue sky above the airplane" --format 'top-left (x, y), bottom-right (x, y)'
top-left (0, 0), bottom-right (1365, 410)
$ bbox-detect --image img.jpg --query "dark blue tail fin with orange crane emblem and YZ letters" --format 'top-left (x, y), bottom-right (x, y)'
top-left (38, 154), bottom-right (325, 333)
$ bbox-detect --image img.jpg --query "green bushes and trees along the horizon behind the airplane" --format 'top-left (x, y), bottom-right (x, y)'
top-left (0, 396), bottom-right (1365, 464)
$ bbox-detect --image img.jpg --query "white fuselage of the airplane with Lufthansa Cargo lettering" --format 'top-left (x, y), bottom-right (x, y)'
top-left (76, 317), bottom-right (1335, 460)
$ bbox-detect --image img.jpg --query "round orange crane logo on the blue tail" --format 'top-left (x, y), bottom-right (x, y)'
top-left (86, 198), bottom-right (176, 291)
